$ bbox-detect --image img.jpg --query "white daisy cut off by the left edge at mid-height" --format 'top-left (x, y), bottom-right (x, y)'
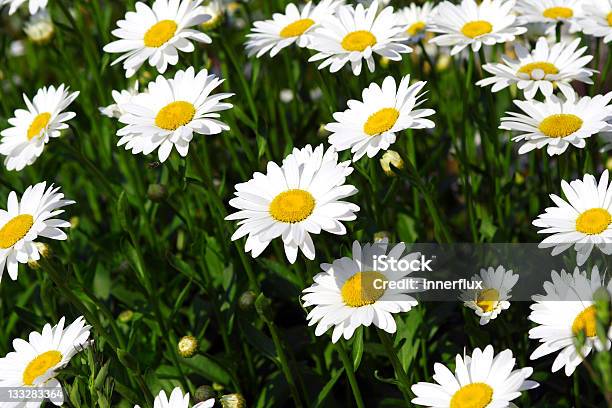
top-left (0, 182), bottom-right (74, 280)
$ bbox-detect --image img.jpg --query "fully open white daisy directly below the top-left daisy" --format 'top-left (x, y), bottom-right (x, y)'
top-left (117, 67), bottom-right (234, 162)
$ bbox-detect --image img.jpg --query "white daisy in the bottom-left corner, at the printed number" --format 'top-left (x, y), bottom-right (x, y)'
top-left (0, 316), bottom-right (91, 407)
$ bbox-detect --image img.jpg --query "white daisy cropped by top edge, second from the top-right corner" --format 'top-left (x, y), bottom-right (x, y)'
top-left (516, 0), bottom-right (584, 32)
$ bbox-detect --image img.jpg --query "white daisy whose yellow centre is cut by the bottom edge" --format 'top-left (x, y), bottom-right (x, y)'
top-left (412, 345), bottom-right (539, 408)
